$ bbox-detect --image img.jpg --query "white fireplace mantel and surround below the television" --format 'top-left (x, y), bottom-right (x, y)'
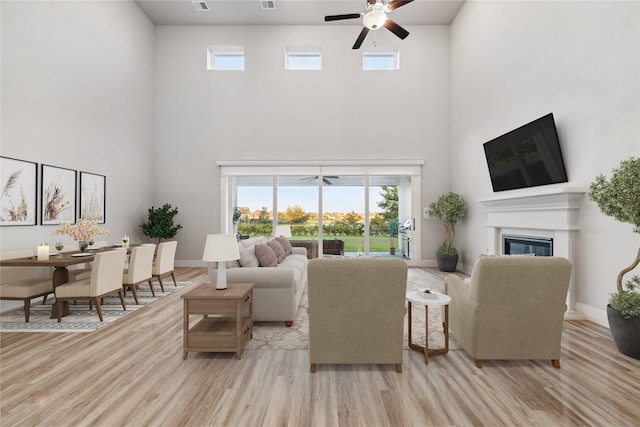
top-left (478, 188), bottom-right (587, 317)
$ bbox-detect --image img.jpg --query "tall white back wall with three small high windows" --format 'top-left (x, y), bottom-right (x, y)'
top-left (155, 25), bottom-right (456, 261)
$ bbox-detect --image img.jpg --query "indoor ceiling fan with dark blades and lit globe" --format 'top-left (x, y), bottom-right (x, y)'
top-left (324, 0), bottom-right (413, 49)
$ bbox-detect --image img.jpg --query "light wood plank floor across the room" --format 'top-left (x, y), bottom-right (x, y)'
top-left (0, 268), bottom-right (640, 427)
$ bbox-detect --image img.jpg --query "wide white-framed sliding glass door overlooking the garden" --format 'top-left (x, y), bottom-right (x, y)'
top-left (221, 164), bottom-right (420, 259)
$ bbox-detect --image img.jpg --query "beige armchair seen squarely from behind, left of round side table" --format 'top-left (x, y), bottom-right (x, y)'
top-left (307, 258), bottom-right (407, 372)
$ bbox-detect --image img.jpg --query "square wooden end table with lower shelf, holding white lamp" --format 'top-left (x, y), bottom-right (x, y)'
top-left (182, 283), bottom-right (254, 359)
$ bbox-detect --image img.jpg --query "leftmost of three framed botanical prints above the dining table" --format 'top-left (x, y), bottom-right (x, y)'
top-left (0, 157), bottom-right (38, 226)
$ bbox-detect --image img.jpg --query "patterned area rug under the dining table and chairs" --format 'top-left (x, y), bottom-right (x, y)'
top-left (0, 281), bottom-right (191, 332)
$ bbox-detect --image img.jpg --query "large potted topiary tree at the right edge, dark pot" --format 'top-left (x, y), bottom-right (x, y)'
top-left (589, 157), bottom-right (640, 359)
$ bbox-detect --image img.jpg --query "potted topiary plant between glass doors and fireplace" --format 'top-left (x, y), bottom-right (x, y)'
top-left (427, 192), bottom-right (467, 272)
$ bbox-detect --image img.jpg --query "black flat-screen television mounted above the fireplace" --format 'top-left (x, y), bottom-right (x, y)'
top-left (484, 113), bottom-right (567, 191)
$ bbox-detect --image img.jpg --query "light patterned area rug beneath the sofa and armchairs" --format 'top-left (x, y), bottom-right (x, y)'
top-left (245, 277), bottom-right (460, 350)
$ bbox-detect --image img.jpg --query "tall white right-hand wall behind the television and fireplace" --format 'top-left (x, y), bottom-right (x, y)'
top-left (450, 1), bottom-right (640, 324)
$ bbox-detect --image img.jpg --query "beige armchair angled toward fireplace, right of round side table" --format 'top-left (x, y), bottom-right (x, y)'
top-left (445, 256), bottom-right (571, 368)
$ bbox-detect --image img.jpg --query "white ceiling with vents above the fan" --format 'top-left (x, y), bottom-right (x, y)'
top-left (135, 0), bottom-right (464, 26)
